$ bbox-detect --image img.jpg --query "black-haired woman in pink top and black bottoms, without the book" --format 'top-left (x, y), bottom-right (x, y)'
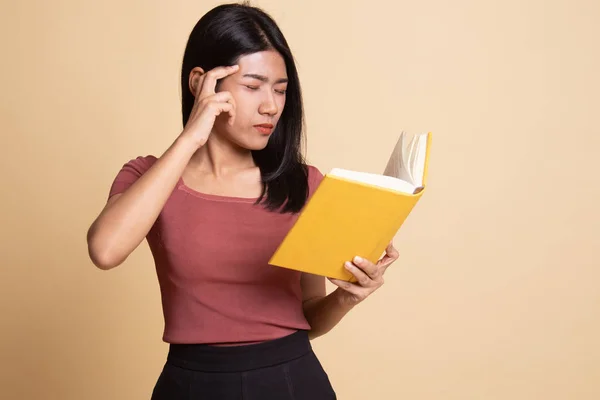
top-left (88, 4), bottom-right (398, 400)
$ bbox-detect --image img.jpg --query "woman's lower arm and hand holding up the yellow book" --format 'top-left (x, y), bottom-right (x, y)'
top-left (301, 242), bottom-right (398, 339)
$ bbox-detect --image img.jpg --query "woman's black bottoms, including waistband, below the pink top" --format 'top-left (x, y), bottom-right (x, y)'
top-left (151, 331), bottom-right (337, 400)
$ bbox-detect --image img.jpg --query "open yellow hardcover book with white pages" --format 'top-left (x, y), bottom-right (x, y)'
top-left (269, 132), bottom-right (431, 282)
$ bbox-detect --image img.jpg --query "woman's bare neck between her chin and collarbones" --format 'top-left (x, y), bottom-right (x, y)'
top-left (190, 133), bottom-right (256, 177)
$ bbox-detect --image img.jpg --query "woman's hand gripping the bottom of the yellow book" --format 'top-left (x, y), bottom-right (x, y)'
top-left (329, 242), bottom-right (398, 306)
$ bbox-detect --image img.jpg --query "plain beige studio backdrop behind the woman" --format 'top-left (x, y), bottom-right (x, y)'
top-left (0, 0), bottom-right (600, 400)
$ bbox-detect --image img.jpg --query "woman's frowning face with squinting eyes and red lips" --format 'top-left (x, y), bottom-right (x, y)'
top-left (213, 50), bottom-right (288, 150)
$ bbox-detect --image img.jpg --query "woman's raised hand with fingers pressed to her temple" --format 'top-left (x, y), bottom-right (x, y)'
top-left (181, 65), bottom-right (239, 147)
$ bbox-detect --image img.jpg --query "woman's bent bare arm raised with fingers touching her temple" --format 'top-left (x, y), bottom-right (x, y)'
top-left (87, 66), bottom-right (237, 269)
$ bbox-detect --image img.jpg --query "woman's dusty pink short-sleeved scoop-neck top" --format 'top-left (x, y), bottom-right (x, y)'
top-left (109, 156), bottom-right (323, 344)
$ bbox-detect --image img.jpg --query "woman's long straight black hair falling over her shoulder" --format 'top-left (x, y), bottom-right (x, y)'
top-left (181, 3), bottom-right (308, 213)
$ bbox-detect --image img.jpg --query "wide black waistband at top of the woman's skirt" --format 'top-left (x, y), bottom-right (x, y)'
top-left (167, 330), bottom-right (312, 372)
